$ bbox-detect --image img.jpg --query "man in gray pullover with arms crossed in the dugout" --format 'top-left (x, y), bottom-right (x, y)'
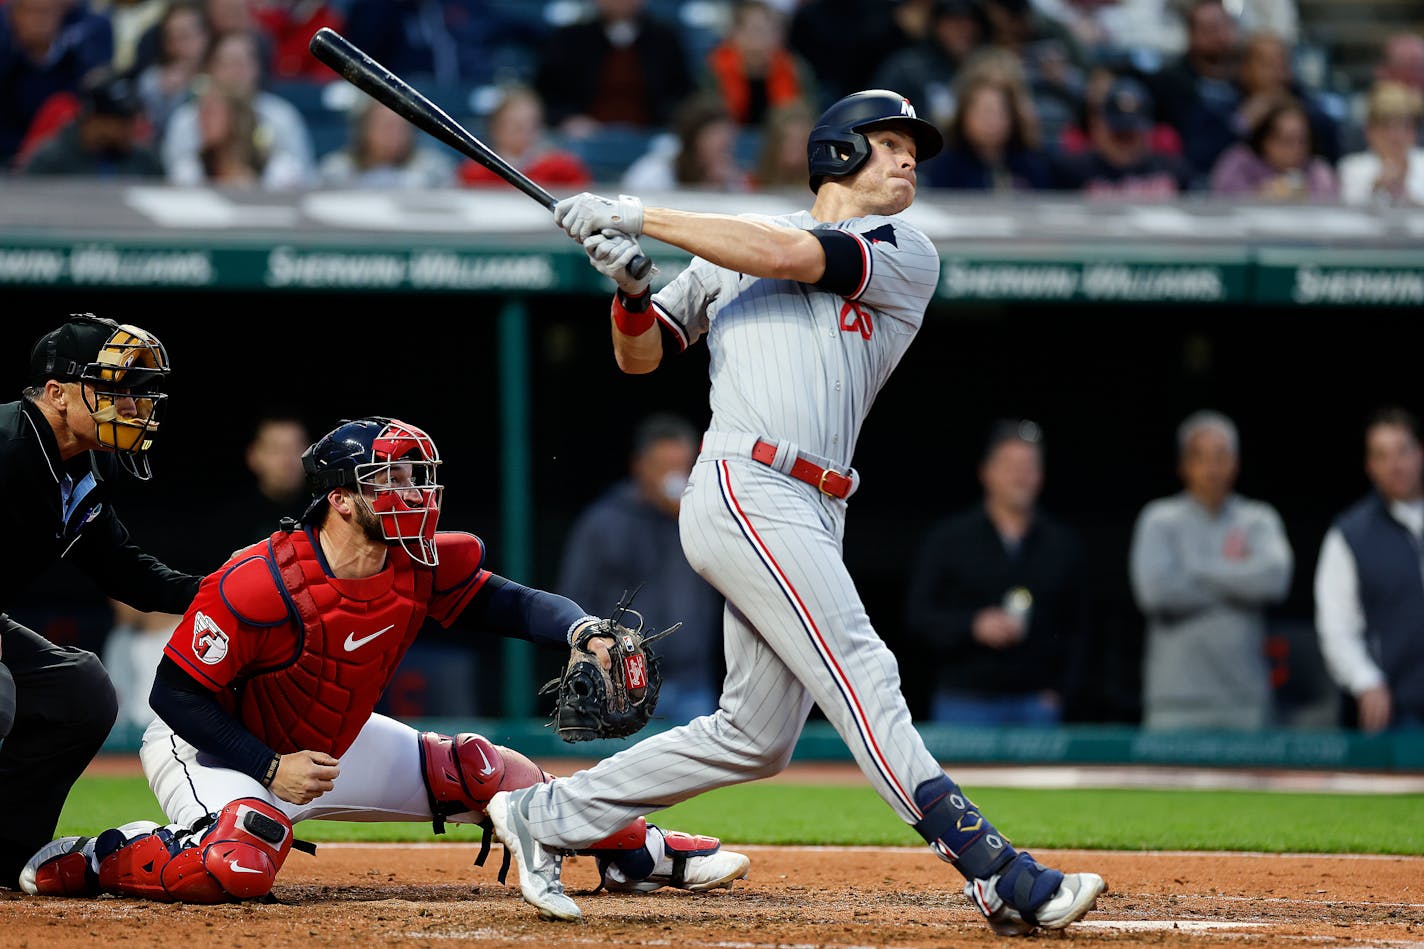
top-left (1129, 412), bottom-right (1294, 730)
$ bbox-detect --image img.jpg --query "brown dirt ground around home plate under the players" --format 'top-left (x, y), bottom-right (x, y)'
top-left (0, 844), bottom-right (1424, 949)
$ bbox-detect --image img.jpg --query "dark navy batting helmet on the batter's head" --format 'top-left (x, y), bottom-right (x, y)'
top-left (806, 88), bottom-right (944, 191)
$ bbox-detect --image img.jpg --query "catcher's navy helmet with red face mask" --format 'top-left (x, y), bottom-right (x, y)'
top-left (302, 416), bottom-right (444, 567)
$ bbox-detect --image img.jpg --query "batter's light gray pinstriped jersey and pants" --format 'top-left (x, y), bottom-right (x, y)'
top-left (511, 206), bottom-right (943, 848)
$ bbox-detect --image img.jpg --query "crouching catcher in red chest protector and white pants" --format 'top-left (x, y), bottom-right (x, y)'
top-left (20, 418), bottom-right (749, 903)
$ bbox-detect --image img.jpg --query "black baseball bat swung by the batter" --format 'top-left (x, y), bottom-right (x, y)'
top-left (309, 27), bottom-right (652, 279)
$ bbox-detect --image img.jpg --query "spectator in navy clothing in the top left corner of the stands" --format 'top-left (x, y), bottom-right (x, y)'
top-left (0, 0), bottom-right (114, 168)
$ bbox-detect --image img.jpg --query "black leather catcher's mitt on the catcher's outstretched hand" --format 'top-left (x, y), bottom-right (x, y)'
top-left (538, 597), bottom-right (682, 741)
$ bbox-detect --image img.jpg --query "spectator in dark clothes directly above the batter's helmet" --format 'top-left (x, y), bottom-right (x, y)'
top-left (873, 0), bottom-right (987, 128)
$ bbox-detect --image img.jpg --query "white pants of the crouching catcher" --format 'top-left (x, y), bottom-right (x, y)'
top-left (138, 706), bottom-right (464, 826)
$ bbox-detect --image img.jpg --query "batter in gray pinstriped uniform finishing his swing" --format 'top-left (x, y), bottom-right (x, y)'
top-left (488, 90), bottom-right (1104, 935)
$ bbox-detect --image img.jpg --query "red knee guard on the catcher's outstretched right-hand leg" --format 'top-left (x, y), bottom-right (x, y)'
top-left (420, 731), bottom-right (553, 834)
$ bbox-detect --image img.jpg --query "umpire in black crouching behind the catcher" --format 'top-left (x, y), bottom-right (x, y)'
top-left (0, 313), bottom-right (199, 889)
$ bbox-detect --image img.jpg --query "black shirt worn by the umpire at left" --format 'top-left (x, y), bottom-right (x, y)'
top-left (0, 399), bottom-right (201, 614)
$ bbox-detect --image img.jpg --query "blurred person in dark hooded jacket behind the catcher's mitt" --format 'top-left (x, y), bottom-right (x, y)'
top-left (558, 413), bottom-right (723, 724)
